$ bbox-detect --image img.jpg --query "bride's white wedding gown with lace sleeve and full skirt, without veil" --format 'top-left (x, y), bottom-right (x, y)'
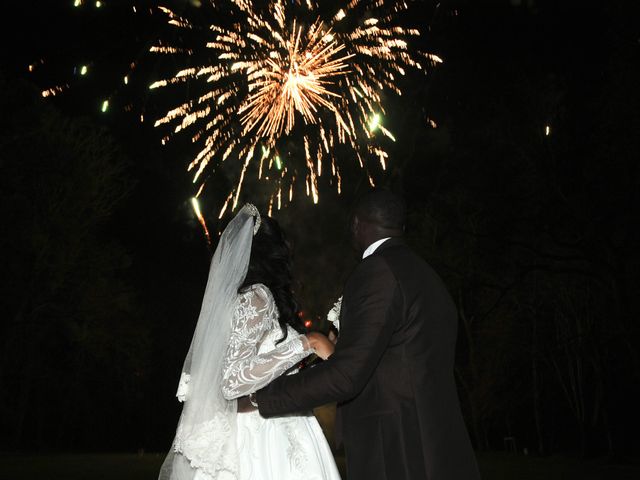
top-left (194, 284), bottom-right (340, 480)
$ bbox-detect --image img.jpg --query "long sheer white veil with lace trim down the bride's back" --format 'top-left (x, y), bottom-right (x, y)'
top-left (159, 204), bottom-right (260, 480)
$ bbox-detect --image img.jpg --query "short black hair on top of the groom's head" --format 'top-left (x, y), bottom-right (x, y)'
top-left (353, 188), bottom-right (406, 230)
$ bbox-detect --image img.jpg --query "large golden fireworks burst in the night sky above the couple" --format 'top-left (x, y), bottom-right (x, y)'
top-left (151, 0), bottom-right (441, 217)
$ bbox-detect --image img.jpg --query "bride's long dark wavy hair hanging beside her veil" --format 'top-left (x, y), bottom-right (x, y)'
top-left (239, 216), bottom-right (306, 343)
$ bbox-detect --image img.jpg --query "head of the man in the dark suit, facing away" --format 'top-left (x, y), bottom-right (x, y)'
top-left (351, 188), bottom-right (406, 252)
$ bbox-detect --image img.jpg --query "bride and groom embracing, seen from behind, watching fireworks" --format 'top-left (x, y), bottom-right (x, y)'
top-left (160, 189), bottom-right (480, 480)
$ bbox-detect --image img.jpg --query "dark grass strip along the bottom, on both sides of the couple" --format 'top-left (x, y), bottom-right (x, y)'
top-left (0, 453), bottom-right (640, 480)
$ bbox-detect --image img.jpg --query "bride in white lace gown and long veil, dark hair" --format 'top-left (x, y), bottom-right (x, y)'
top-left (159, 204), bottom-right (340, 480)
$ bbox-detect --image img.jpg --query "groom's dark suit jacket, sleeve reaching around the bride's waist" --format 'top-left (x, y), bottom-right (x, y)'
top-left (257, 238), bottom-right (480, 480)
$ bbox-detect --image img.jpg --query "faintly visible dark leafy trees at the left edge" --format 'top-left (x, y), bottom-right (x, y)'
top-left (0, 72), bottom-right (144, 448)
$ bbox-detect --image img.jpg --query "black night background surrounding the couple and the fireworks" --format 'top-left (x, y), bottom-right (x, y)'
top-left (0, 0), bottom-right (640, 464)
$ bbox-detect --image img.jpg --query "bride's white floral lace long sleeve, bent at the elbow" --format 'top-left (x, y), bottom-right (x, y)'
top-left (222, 288), bottom-right (312, 400)
